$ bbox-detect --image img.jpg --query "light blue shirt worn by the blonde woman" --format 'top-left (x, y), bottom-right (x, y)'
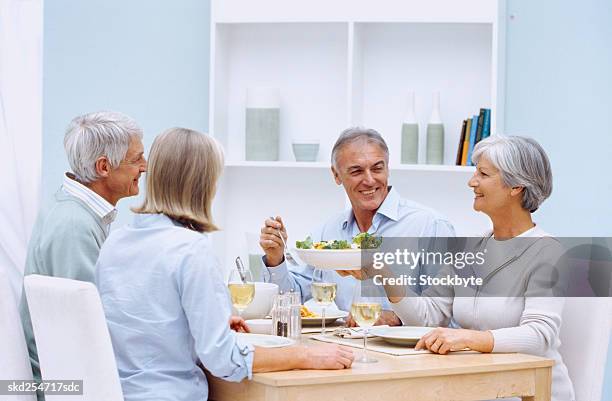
top-left (96, 214), bottom-right (254, 401)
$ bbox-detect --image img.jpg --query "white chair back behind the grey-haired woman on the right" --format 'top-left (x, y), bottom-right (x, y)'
top-left (560, 298), bottom-right (612, 401)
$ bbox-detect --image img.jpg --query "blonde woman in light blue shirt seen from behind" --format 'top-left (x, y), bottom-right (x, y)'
top-left (96, 128), bottom-right (353, 401)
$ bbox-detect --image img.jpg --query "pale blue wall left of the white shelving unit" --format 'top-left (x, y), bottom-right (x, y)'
top-left (42, 0), bottom-right (210, 226)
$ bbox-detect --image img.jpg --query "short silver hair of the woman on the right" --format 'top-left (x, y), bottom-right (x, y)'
top-left (472, 135), bottom-right (553, 213)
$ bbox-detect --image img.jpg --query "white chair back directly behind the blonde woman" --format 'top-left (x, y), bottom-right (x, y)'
top-left (24, 275), bottom-right (123, 401)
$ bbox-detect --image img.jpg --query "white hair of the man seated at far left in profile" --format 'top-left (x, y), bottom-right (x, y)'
top-left (64, 111), bottom-right (142, 184)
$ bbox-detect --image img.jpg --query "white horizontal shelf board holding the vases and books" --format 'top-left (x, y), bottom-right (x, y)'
top-left (225, 161), bottom-right (474, 174)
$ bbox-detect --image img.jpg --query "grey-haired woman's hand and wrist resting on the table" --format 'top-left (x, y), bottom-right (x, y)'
top-left (414, 327), bottom-right (493, 355)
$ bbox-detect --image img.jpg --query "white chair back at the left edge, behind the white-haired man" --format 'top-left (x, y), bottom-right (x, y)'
top-left (0, 270), bottom-right (36, 401)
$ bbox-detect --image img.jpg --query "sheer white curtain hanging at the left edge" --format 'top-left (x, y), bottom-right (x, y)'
top-left (0, 0), bottom-right (43, 299)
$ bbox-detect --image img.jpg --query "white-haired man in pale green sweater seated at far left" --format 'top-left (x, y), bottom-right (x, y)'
top-left (20, 112), bottom-right (147, 399)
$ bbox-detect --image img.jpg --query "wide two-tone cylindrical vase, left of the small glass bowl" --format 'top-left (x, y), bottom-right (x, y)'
top-left (245, 88), bottom-right (280, 161)
